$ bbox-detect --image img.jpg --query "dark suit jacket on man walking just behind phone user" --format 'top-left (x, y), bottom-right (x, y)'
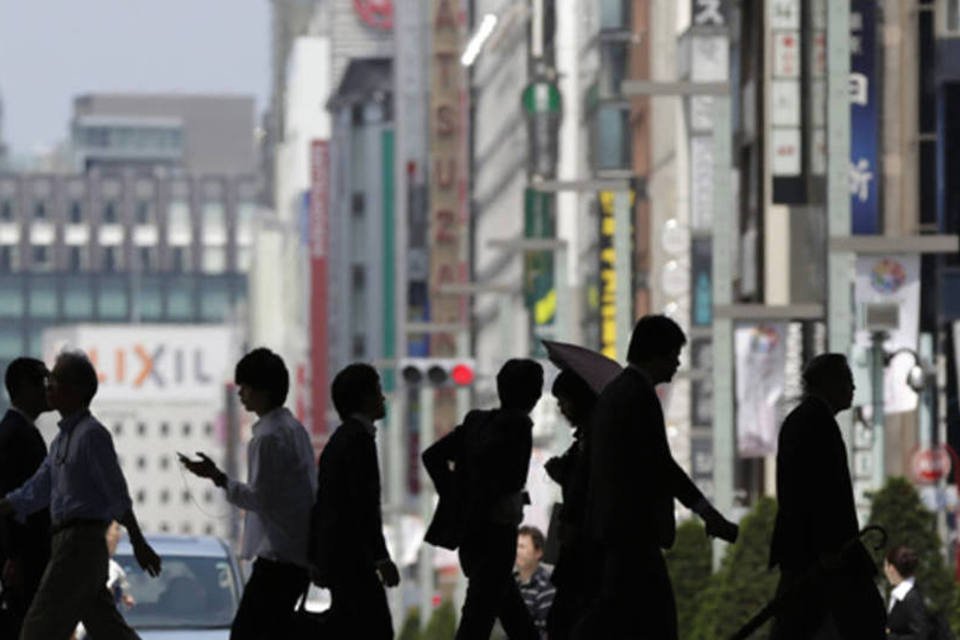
top-left (310, 419), bottom-right (389, 579)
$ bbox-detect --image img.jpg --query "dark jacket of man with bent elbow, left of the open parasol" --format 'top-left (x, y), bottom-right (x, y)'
top-left (423, 409), bottom-right (533, 549)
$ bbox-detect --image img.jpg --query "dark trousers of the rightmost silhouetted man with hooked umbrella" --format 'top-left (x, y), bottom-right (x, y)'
top-left (770, 571), bottom-right (887, 640)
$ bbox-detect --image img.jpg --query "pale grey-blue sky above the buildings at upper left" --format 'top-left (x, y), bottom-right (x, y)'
top-left (0, 0), bottom-right (270, 154)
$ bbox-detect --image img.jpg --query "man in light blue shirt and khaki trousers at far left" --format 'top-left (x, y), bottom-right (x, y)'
top-left (0, 353), bottom-right (160, 640)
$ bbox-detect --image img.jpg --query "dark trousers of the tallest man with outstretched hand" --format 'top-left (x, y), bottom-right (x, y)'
top-left (571, 545), bottom-right (677, 640)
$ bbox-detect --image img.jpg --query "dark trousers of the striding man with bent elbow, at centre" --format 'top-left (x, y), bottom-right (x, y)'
top-left (456, 524), bottom-right (540, 640)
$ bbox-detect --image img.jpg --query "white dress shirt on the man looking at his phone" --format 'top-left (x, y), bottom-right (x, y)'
top-left (226, 407), bottom-right (317, 567)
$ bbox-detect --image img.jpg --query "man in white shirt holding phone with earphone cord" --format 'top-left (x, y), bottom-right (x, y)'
top-left (186, 348), bottom-right (317, 640)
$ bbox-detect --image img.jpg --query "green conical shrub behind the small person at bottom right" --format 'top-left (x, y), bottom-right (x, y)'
top-left (865, 478), bottom-right (956, 611)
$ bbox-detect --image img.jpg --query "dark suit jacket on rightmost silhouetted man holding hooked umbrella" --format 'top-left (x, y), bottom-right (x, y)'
top-left (770, 398), bottom-right (875, 571)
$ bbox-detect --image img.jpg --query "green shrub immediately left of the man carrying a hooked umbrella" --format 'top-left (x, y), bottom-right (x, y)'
top-left (681, 498), bottom-right (779, 640)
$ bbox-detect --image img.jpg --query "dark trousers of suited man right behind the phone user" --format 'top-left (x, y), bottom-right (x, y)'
top-left (324, 561), bottom-right (393, 640)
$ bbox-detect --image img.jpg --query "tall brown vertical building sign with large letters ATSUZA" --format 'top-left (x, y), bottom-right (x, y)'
top-left (428, 0), bottom-right (468, 356)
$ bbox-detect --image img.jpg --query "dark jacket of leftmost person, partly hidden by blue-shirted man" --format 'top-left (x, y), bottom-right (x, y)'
top-left (0, 410), bottom-right (50, 566)
